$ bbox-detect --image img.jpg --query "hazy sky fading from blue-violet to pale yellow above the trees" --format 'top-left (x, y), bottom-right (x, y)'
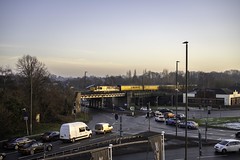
top-left (0, 0), bottom-right (240, 77)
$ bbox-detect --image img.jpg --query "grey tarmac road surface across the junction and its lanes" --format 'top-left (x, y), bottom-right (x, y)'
top-left (1, 109), bottom-right (240, 160)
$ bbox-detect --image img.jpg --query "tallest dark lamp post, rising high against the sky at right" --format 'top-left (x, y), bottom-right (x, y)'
top-left (183, 41), bottom-right (188, 160)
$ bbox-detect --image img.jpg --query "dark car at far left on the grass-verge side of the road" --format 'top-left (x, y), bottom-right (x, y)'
top-left (3, 137), bottom-right (32, 150)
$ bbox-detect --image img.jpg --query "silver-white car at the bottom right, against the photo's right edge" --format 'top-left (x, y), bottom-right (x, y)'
top-left (214, 139), bottom-right (240, 153)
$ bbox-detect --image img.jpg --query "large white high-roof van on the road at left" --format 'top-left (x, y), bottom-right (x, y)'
top-left (60, 122), bottom-right (92, 142)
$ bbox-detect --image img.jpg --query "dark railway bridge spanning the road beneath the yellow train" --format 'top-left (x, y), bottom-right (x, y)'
top-left (74, 90), bottom-right (182, 112)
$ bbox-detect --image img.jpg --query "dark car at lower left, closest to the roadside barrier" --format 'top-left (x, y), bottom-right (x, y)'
top-left (18, 141), bottom-right (52, 155)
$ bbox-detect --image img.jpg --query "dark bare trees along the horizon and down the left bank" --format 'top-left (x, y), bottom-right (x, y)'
top-left (0, 55), bottom-right (240, 139)
